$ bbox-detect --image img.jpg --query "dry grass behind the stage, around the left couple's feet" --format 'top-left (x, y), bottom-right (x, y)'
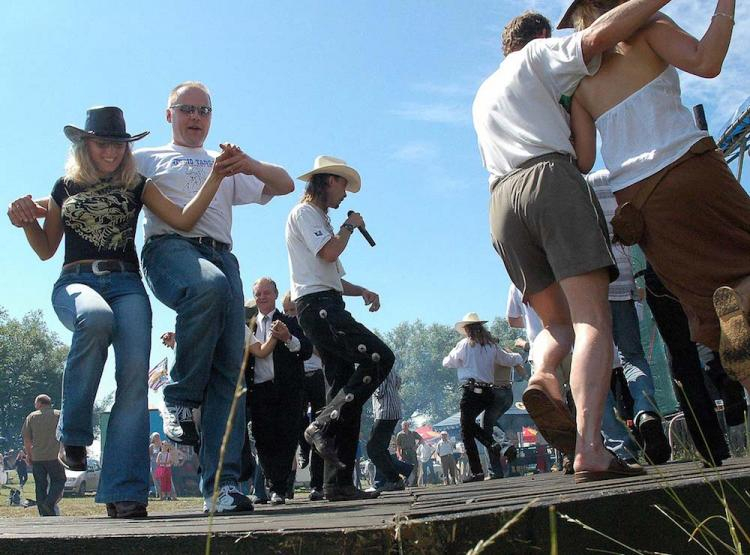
top-left (0, 472), bottom-right (203, 518)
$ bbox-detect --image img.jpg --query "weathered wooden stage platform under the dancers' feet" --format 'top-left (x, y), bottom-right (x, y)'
top-left (0, 458), bottom-right (750, 555)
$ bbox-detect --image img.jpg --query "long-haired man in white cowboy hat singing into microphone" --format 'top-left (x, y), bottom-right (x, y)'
top-left (286, 156), bottom-right (395, 501)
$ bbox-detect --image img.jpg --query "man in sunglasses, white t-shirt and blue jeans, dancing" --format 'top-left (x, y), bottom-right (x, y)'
top-left (135, 81), bottom-right (294, 513)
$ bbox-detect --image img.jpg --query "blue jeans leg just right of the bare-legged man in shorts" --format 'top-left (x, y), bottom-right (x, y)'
top-left (609, 300), bottom-right (659, 422)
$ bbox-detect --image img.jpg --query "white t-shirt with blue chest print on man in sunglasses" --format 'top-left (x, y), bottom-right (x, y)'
top-left (133, 143), bottom-right (272, 245)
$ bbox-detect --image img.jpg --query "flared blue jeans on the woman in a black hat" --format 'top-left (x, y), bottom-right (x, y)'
top-left (52, 272), bottom-right (151, 504)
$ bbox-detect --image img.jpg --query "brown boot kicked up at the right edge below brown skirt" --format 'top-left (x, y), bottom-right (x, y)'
top-left (714, 277), bottom-right (750, 383)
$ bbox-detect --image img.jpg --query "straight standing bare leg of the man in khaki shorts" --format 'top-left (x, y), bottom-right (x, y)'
top-left (560, 269), bottom-right (612, 471)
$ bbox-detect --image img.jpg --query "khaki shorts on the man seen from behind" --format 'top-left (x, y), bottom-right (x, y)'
top-left (490, 153), bottom-right (618, 298)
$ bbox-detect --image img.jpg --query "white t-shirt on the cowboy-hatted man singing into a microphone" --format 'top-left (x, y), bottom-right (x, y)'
top-left (285, 202), bottom-right (345, 301)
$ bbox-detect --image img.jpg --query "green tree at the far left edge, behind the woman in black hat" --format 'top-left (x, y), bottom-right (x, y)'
top-left (0, 307), bottom-right (68, 444)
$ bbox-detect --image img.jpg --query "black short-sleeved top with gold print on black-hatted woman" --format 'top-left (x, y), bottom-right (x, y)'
top-left (52, 176), bottom-right (146, 265)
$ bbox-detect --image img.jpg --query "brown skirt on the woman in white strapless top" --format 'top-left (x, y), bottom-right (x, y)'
top-left (615, 146), bottom-right (750, 350)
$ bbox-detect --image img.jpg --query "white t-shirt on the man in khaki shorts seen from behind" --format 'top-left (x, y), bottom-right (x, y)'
top-left (472, 33), bottom-right (601, 183)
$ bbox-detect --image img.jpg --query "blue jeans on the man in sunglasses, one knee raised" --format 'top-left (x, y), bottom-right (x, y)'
top-left (141, 235), bottom-right (245, 496)
